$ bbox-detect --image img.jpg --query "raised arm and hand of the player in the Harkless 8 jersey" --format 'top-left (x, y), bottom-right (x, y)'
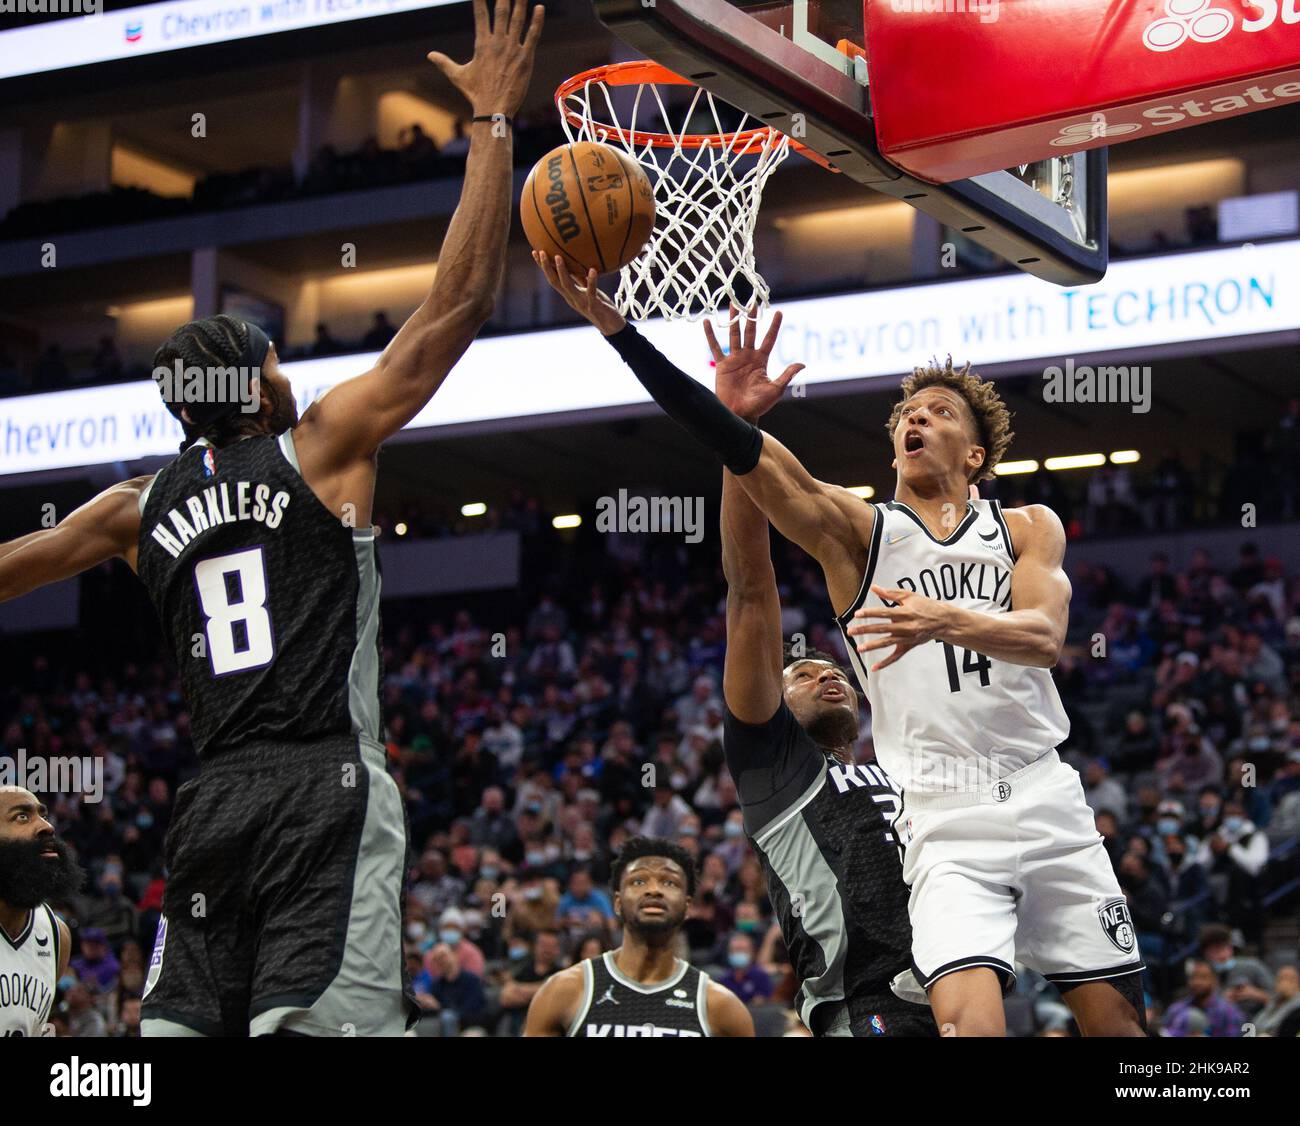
top-left (294, 0), bottom-right (542, 470)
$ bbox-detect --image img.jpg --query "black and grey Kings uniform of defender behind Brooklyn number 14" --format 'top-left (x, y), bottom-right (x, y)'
top-left (723, 700), bottom-right (919, 1036)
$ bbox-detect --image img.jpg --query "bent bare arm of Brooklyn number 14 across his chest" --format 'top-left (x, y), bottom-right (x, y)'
top-left (848, 504), bottom-right (1070, 672)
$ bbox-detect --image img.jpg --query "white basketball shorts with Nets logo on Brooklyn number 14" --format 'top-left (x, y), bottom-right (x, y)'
top-left (898, 750), bottom-right (1143, 991)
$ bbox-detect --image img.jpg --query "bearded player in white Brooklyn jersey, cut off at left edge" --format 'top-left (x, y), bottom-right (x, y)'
top-left (0, 785), bottom-right (82, 1036)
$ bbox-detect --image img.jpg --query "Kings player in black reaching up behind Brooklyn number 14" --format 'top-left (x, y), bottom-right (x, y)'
top-left (710, 313), bottom-right (939, 1036)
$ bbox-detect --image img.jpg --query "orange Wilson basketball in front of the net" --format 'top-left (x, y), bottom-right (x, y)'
top-left (519, 140), bottom-right (655, 276)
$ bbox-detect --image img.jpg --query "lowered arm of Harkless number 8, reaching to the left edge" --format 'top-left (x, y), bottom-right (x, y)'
top-left (0, 476), bottom-right (153, 602)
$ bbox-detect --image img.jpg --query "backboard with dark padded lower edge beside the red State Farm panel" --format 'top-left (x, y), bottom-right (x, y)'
top-left (593, 0), bottom-right (1108, 285)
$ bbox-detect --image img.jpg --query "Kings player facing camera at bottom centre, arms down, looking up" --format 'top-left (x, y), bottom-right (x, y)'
top-left (524, 837), bottom-right (754, 1038)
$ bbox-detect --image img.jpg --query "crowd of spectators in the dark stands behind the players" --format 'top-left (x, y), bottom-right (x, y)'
top-left (0, 483), bottom-right (1300, 1035)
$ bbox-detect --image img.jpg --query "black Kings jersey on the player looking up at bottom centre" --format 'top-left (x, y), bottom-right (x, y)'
top-left (568, 950), bottom-right (712, 1038)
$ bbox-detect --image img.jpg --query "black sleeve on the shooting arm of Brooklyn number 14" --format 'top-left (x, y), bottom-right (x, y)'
top-left (606, 322), bottom-right (763, 476)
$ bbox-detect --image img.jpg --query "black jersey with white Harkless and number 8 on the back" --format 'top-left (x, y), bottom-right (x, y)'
top-left (139, 430), bottom-right (380, 754)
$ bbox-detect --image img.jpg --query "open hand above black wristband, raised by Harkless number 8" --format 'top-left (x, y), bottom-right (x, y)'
top-left (426, 0), bottom-right (546, 117)
